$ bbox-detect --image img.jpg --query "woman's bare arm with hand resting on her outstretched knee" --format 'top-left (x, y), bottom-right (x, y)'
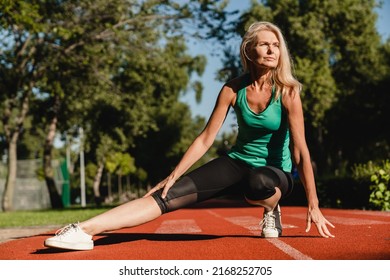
top-left (145, 85), bottom-right (235, 198)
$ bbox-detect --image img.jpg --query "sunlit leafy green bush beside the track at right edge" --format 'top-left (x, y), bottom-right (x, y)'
top-left (352, 160), bottom-right (390, 211)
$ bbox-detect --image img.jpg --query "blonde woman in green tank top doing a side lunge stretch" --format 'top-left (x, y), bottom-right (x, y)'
top-left (45, 22), bottom-right (334, 250)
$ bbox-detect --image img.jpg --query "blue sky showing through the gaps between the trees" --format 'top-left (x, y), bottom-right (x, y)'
top-left (182, 0), bottom-right (390, 134)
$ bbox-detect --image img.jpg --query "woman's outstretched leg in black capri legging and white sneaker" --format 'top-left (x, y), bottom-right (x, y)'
top-left (45, 157), bottom-right (247, 250)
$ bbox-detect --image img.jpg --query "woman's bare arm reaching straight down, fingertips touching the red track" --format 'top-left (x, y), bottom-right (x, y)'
top-left (283, 93), bottom-right (334, 237)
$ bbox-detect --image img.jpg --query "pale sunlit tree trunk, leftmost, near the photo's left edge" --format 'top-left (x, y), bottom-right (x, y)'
top-left (2, 137), bottom-right (19, 212)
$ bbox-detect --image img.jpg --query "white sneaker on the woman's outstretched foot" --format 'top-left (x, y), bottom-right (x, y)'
top-left (44, 223), bottom-right (93, 250)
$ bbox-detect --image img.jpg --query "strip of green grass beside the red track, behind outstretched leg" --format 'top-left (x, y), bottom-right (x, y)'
top-left (0, 207), bottom-right (111, 228)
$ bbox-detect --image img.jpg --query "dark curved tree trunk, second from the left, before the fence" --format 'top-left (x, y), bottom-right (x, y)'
top-left (43, 113), bottom-right (64, 209)
